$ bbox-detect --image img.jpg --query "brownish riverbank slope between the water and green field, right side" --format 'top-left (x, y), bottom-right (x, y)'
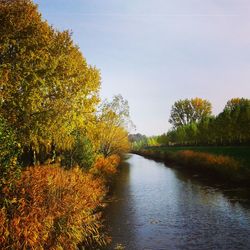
top-left (132, 147), bottom-right (250, 186)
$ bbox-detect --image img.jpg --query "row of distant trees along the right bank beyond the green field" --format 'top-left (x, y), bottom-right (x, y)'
top-left (130, 98), bottom-right (250, 148)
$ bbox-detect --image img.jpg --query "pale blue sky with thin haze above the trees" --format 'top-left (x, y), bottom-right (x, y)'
top-left (34, 0), bottom-right (250, 136)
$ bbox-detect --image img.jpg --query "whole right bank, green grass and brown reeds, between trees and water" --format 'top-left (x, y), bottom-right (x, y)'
top-left (133, 147), bottom-right (250, 185)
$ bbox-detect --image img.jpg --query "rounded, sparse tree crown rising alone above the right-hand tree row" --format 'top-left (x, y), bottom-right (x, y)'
top-left (169, 98), bottom-right (212, 128)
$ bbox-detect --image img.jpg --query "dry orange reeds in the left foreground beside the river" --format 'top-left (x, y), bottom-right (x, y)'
top-left (0, 165), bottom-right (107, 249)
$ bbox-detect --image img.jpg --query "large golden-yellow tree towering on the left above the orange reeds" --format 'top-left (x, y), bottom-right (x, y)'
top-left (0, 0), bottom-right (100, 164)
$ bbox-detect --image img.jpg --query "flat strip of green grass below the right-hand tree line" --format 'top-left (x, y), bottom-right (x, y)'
top-left (146, 146), bottom-right (250, 168)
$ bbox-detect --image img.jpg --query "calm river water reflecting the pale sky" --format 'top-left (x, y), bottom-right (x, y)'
top-left (106, 155), bottom-right (250, 250)
